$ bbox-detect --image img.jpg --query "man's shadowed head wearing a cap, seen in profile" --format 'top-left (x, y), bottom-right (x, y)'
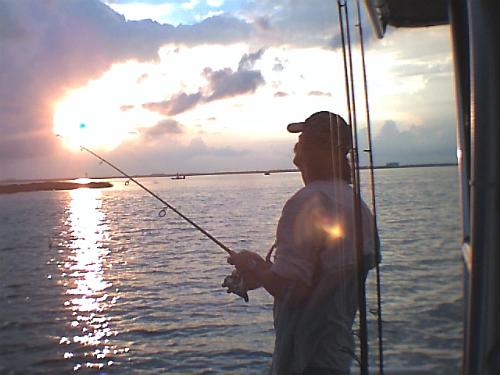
top-left (287, 111), bottom-right (351, 183)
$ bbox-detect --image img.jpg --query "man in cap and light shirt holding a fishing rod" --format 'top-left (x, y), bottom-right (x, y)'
top-left (228, 111), bottom-right (375, 375)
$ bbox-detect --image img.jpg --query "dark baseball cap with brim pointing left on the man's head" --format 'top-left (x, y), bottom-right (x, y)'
top-left (287, 111), bottom-right (351, 152)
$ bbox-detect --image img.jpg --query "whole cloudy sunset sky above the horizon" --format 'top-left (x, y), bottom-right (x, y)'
top-left (0, 0), bottom-right (456, 180)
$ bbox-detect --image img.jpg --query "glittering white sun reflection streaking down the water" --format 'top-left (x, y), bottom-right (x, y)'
top-left (59, 189), bottom-right (122, 371)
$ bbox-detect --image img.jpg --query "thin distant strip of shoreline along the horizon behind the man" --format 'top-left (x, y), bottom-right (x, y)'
top-left (0, 163), bottom-right (458, 184)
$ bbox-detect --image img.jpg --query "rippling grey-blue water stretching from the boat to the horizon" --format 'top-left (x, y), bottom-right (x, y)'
top-left (0, 167), bottom-right (463, 374)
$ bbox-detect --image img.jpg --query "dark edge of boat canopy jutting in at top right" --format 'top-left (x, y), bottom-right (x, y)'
top-left (365, 0), bottom-right (448, 38)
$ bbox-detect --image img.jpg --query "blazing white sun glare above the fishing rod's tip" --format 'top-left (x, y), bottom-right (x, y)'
top-left (53, 63), bottom-right (162, 151)
